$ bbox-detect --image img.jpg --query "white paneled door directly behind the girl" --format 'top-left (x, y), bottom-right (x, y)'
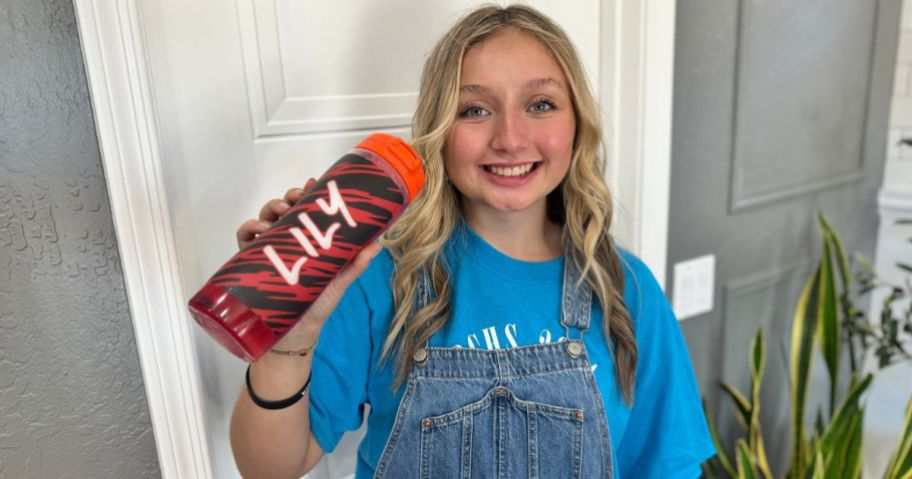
top-left (138, 0), bottom-right (600, 478)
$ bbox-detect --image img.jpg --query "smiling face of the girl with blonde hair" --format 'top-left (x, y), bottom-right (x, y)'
top-left (444, 28), bottom-right (576, 223)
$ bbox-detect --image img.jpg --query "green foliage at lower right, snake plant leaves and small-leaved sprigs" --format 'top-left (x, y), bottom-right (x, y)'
top-left (704, 214), bottom-right (912, 479)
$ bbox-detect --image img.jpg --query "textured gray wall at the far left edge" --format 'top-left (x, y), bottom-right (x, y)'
top-left (0, 0), bottom-right (159, 478)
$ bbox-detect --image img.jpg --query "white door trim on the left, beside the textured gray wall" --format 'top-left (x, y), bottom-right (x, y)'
top-left (74, 0), bottom-right (212, 479)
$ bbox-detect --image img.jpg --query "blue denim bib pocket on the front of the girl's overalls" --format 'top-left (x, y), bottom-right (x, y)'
top-left (420, 387), bottom-right (584, 479)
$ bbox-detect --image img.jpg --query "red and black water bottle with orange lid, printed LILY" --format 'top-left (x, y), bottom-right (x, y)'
top-left (189, 133), bottom-right (424, 362)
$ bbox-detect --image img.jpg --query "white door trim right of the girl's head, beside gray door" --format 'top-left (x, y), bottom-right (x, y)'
top-left (599, 0), bottom-right (675, 287)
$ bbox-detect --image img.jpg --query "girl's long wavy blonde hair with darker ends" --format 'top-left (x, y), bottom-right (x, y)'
top-left (383, 5), bottom-right (637, 403)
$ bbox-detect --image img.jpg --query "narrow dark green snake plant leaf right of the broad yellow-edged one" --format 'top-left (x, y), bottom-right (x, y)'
top-left (817, 240), bottom-right (840, 417)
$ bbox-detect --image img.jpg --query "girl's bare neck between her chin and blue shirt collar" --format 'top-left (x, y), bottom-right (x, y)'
top-left (463, 204), bottom-right (563, 261)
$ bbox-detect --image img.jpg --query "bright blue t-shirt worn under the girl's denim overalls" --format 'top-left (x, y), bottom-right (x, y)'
top-left (310, 223), bottom-right (715, 478)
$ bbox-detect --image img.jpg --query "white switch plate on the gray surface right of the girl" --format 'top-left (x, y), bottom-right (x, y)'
top-left (672, 254), bottom-right (716, 321)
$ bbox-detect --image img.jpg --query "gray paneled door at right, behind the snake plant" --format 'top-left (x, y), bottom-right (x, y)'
top-left (666, 0), bottom-right (901, 472)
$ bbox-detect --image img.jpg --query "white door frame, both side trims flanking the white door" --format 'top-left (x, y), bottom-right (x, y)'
top-left (74, 0), bottom-right (675, 479)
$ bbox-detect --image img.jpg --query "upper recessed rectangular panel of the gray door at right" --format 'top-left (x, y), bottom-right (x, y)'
top-left (731, 0), bottom-right (877, 211)
